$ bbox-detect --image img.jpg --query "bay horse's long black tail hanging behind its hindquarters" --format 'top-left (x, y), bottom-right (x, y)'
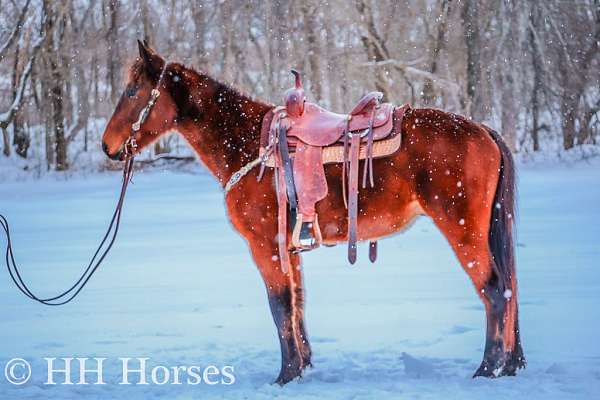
top-left (488, 129), bottom-right (517, 294)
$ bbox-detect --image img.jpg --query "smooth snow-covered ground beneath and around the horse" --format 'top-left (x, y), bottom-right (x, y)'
top-left (0, 160), bottom-right (600, 400)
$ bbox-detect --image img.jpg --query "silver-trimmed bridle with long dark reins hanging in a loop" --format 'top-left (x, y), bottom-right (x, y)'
top-left (0, 61), bottom-right (168, 306)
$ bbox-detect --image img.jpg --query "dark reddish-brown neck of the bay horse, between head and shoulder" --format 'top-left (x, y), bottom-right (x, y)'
top-left (180, 78), bottom-right (271, 185)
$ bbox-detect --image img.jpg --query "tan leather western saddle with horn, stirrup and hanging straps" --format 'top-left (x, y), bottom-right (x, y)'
top-left (258, 70), bottom-right (408, 271)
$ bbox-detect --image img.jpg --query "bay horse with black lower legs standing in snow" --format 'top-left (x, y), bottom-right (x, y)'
top-left (102, 42), bottom-right (525, 385)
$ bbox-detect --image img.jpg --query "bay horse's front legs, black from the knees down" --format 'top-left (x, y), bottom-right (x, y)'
top-left (249, 241), bottom-right (311, 385)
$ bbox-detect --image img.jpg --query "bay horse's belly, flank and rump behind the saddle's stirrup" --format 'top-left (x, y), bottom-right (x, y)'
top-left (317, 109), bottom-right (501, 243)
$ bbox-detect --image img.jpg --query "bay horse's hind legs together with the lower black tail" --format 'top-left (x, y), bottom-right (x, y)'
top-left (421, 164), bottom-right (525, 377)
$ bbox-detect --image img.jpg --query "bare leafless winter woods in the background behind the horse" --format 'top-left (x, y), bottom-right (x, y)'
top-left (0, 0), bottom-right (600, 170)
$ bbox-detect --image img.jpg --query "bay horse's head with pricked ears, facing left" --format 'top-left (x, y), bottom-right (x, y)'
top-left (102, 41), bottom-right (177, 160)
